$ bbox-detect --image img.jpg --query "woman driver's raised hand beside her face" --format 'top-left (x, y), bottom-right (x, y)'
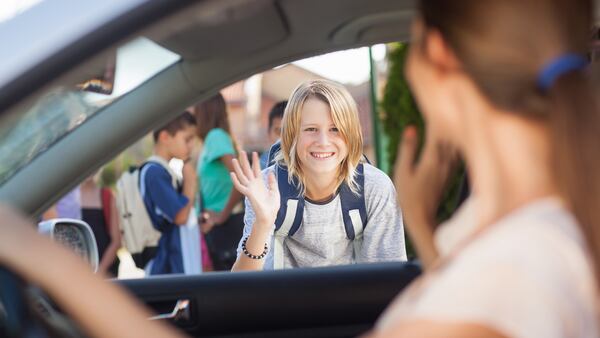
top-left (394, 126), bottom-right (457, 268)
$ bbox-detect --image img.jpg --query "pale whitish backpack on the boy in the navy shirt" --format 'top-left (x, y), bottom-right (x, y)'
top-left (116, 157), bottom-right (177, 268)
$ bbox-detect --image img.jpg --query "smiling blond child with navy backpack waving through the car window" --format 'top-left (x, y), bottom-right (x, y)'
top-left (231, 80), bottom-right (406, 271)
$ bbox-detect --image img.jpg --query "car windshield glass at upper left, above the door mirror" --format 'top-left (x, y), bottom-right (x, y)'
top-left (0, 38), bottom-right (180, 184)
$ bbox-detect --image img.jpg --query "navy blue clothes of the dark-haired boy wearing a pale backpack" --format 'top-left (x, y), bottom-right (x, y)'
top-left (140, 162), bottom-right (189, 275)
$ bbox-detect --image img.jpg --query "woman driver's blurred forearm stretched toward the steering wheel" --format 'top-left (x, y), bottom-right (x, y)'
top-left (9, 232), bottom-right (182, 337)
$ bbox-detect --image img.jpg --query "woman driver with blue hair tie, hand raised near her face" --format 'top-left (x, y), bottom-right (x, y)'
top-left (374, 0), bottom-right (600, 338)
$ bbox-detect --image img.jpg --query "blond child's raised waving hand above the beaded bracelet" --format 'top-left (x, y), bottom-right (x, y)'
top-left (231, 151), bottom-right (279, 230)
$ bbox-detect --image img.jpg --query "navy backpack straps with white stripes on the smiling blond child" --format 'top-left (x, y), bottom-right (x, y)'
top-left (267, 141), bottom-right (369, 269)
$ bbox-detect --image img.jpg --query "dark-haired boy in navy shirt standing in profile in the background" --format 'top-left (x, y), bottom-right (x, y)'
top-left (139, 112), bottom-right (200, 275)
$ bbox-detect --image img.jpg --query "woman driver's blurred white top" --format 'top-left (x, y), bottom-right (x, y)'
top-left (376, 198), bottom-right (600, 338)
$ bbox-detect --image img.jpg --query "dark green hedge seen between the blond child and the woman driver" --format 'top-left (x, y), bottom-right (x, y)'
top-left (380, 43), bottom-right (465, 258)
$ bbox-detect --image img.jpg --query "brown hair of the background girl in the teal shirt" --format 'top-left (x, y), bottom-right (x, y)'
top-left (194, 93), bottom-right (231, 141)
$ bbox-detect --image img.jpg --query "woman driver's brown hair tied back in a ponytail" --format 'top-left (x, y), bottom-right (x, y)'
top-left (420, 0), bottom-right (600, 280)
